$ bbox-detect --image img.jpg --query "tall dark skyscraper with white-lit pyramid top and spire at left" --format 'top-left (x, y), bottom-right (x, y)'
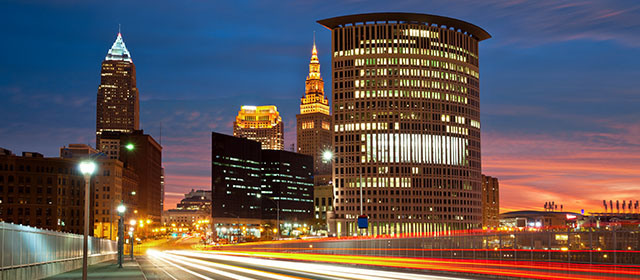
top-left (96, 32), bottom-right (140, 149)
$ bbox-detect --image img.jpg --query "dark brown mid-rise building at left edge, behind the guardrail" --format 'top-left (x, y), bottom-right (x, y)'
top-left (0, 148), bottom-right (93, 235)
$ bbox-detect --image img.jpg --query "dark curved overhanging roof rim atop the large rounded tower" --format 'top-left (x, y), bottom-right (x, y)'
top-left (318, 13), bottom-right (491, 41)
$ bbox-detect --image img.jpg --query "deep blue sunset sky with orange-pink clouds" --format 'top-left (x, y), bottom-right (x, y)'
top-left (0, 0), bottom-right (640, 212)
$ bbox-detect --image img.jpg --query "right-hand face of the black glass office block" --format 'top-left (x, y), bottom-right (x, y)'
top-left (261, 150), bottom-right (313, 223)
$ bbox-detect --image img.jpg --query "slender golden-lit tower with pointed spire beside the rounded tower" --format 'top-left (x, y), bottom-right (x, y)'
top-left (296, 41), bottom-right (332, 179)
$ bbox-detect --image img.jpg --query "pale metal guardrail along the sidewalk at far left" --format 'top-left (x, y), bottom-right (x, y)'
top-left (0, 222), bottom-right (117, 270)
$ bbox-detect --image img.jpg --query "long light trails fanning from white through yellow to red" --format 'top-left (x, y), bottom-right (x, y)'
top-left (149, 250), bottom-right (640, 280)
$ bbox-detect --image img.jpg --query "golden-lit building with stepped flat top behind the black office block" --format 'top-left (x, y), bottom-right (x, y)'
top-left (233, 105), bottom-right (284, 150)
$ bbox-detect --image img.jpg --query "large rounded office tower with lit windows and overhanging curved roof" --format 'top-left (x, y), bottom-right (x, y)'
top-left (318, 13), bottom-right (491, 234)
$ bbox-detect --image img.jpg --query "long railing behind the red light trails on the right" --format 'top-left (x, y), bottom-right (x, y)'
top-left (239, 229), bottom-right (640, 265)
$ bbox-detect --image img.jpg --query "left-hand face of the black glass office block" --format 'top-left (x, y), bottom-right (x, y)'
top-left (211, 132), bottom-right (262, 220)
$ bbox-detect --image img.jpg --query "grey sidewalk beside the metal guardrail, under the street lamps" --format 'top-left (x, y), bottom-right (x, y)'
top-left (45, 258), bottom-right (146, 280)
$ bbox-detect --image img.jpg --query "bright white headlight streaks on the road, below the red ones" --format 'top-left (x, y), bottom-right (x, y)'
top-left (137, 250), bottom-right (470, 280)
